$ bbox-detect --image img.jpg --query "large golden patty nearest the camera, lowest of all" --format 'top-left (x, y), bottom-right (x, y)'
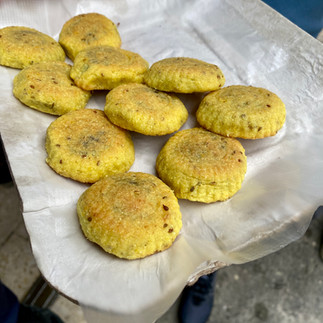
top-left (77, 172), bottom-right (182, 259)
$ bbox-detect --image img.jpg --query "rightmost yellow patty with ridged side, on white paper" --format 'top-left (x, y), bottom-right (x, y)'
top-left (196, 85), bottom-right (286, 139)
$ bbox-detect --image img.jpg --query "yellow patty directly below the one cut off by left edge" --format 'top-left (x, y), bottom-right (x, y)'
top-left (13, 62), bottom-right (91, 115)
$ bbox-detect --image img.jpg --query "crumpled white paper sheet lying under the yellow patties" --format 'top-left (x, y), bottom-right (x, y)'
top-left (0, 0), bottom-right (323, 323)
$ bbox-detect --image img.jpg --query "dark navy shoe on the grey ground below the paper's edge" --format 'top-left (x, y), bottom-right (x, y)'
top-left (178, 272), bottom-right (216, 323)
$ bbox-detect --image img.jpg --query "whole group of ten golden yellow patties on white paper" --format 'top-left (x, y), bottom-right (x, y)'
top-left (0, 13), bottom-right (286, 259)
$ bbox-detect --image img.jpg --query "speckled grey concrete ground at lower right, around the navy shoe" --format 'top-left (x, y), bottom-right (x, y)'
top-left (158, 209), bottom-right (323, 323)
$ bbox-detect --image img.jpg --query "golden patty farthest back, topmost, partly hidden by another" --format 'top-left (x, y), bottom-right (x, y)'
top-left (59, 13), bottom-right (121, 60)
